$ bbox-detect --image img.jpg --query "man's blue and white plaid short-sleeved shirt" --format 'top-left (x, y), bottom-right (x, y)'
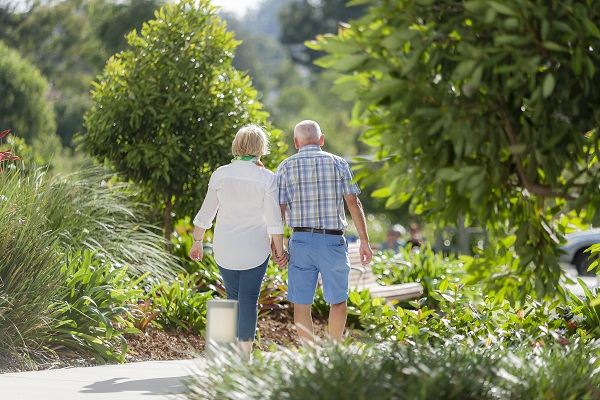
top-left (277, 144), bottom-right (360, 230)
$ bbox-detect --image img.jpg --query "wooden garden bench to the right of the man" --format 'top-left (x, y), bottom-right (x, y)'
top-left (348, 242), bottom-right (423, 300)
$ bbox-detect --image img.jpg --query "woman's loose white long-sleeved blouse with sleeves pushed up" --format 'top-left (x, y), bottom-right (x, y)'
top-left (194, 160), bottom-right (283, 270)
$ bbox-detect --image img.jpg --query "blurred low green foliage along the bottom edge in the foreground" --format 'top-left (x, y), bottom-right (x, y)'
top-left (186, 342), bottom-right (600, 400)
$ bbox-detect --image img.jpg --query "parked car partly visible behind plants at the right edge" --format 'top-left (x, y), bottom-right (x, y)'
top-left (559, 228), bottom-right (600, 276)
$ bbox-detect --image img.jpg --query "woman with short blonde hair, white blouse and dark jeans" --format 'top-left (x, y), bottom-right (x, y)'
top-left (190, 125), bottom-right (287, 355)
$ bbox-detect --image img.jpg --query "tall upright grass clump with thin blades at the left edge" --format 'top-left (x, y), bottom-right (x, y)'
top-left (0, 169), bottom-right (64, 353)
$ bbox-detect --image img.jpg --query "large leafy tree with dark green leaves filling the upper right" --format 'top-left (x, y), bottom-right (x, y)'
top-left (308, 0), bottom-right (600, 298)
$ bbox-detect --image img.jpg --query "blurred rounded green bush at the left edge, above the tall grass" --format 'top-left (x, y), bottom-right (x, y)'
top-left (0, 42), bottom-right (61, 163)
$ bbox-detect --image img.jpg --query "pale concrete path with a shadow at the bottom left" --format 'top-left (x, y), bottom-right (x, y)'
top-left (0, 359), bottom-right (204, 400)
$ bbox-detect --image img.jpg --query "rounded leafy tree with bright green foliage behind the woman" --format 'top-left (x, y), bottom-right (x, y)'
top-left (82, 0), bottom-right (285, 241)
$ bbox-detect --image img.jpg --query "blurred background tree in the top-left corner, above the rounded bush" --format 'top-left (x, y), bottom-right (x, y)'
top-left (3, 0), bottom-right (107, 146)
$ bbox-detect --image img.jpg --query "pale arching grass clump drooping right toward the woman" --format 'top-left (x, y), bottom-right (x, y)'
top-left (44, 167), bottom-right (178, 279)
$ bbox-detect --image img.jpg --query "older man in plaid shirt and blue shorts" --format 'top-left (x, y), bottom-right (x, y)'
top-left (277, 121), bottom-right (373, 342)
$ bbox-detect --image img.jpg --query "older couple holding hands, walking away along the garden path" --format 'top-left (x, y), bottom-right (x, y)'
top-left (190, 120), bottom-right (373, 354)
